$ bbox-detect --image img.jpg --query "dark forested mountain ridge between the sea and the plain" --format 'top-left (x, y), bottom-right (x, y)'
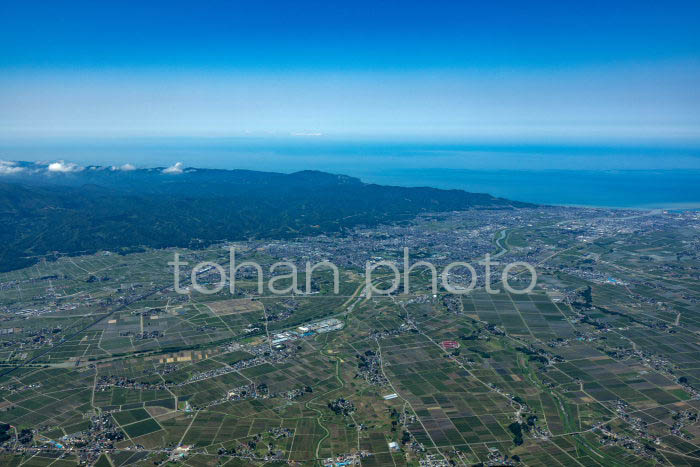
top-left (0, 169), bottom-right (528, 270)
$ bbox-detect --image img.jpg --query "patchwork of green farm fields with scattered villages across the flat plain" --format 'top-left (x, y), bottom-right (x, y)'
top-left (0, 210), bottom-right (700, 466)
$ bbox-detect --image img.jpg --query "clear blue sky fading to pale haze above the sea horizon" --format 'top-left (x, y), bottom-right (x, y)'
top-left (0, 1), bottom-right (700, 142)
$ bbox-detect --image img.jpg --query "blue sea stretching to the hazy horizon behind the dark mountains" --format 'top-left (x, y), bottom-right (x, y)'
top-left (0, 136), bottom-right (700, 209)
